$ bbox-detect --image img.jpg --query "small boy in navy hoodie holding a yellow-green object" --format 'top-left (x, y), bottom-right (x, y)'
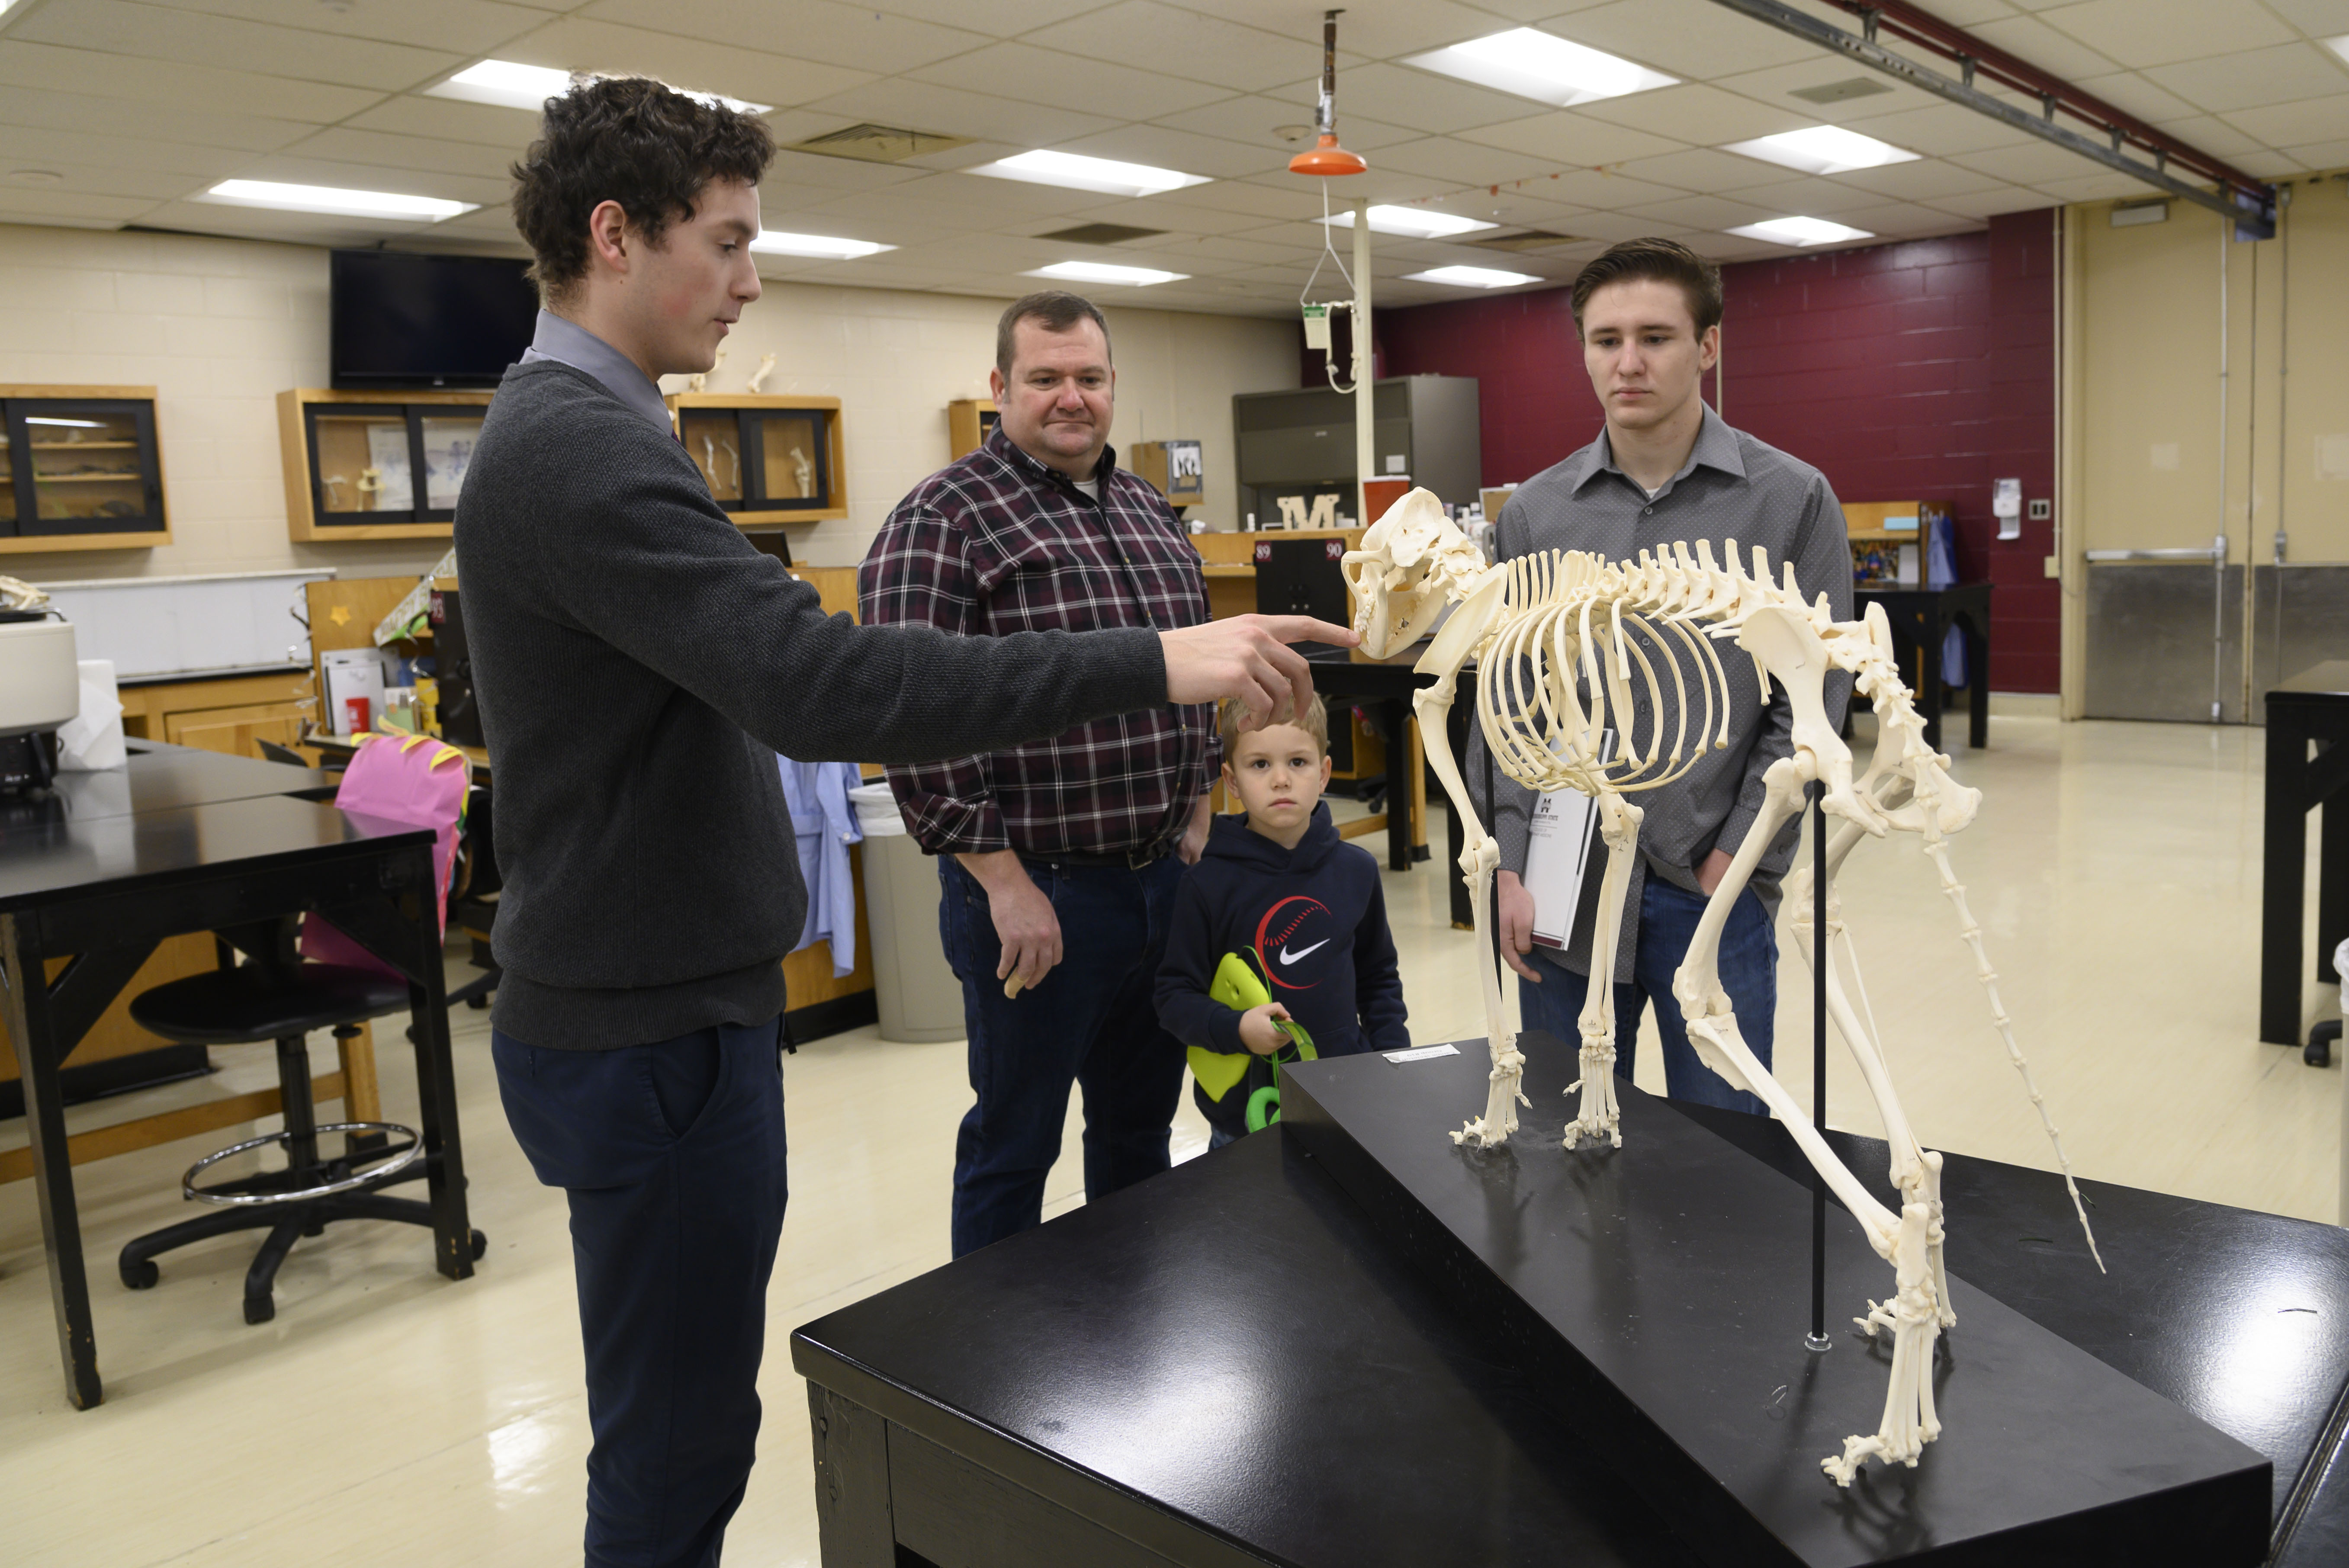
top-left (1158, 697), bottom-right (1412, 1148)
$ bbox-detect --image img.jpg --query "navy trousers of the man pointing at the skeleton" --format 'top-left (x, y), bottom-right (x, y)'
top-left (491, 1019), bottom-right (784, 1568)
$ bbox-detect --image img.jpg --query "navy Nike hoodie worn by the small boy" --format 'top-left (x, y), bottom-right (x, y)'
top-left (1158, 803), bottom-right (1412, 1125)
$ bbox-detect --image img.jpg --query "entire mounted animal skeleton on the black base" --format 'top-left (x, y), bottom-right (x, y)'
top-left (1343, 491), bottom-right (2102, 1486)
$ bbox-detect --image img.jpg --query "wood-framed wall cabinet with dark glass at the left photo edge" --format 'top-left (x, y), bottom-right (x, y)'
top-left (0, 387), bottom-right (171, 554)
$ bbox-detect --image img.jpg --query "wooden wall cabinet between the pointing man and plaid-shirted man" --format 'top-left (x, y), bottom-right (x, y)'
top-left (665, 392), bottom-right (848, 526)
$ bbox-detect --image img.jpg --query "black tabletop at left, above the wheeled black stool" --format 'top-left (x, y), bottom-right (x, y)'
top-left (0, 796), bottom-right (432, 911)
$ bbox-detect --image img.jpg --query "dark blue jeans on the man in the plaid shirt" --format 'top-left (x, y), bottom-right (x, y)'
top-left (937, 855), bottom-right (1184, 1258)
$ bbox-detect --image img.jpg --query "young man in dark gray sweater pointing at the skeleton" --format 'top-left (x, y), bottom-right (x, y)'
top-left (456, 80), bottom-right (1351, 1568)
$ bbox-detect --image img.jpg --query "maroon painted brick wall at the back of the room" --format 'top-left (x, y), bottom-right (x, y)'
top-left (1372, 211), bottom-right (2060, 692)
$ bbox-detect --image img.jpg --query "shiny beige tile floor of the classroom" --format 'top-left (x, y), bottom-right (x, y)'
top-left (0, 716), bottom-right (2342, 1568)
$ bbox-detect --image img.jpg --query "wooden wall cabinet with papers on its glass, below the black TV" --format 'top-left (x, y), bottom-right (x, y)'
top-left (277, 387), bottom-right (491, 545)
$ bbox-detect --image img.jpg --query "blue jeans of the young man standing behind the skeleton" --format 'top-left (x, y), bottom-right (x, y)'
top-left (1517, 876), bottom-right (1778, 1115)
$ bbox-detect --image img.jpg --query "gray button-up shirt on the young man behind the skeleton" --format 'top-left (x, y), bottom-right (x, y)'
top-left (1466, 408), bottom-right (1851, 981)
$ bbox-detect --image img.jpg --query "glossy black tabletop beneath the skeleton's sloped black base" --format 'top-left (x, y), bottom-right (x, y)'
top-left (792, 1084), bottom-right (2349, 1568)
